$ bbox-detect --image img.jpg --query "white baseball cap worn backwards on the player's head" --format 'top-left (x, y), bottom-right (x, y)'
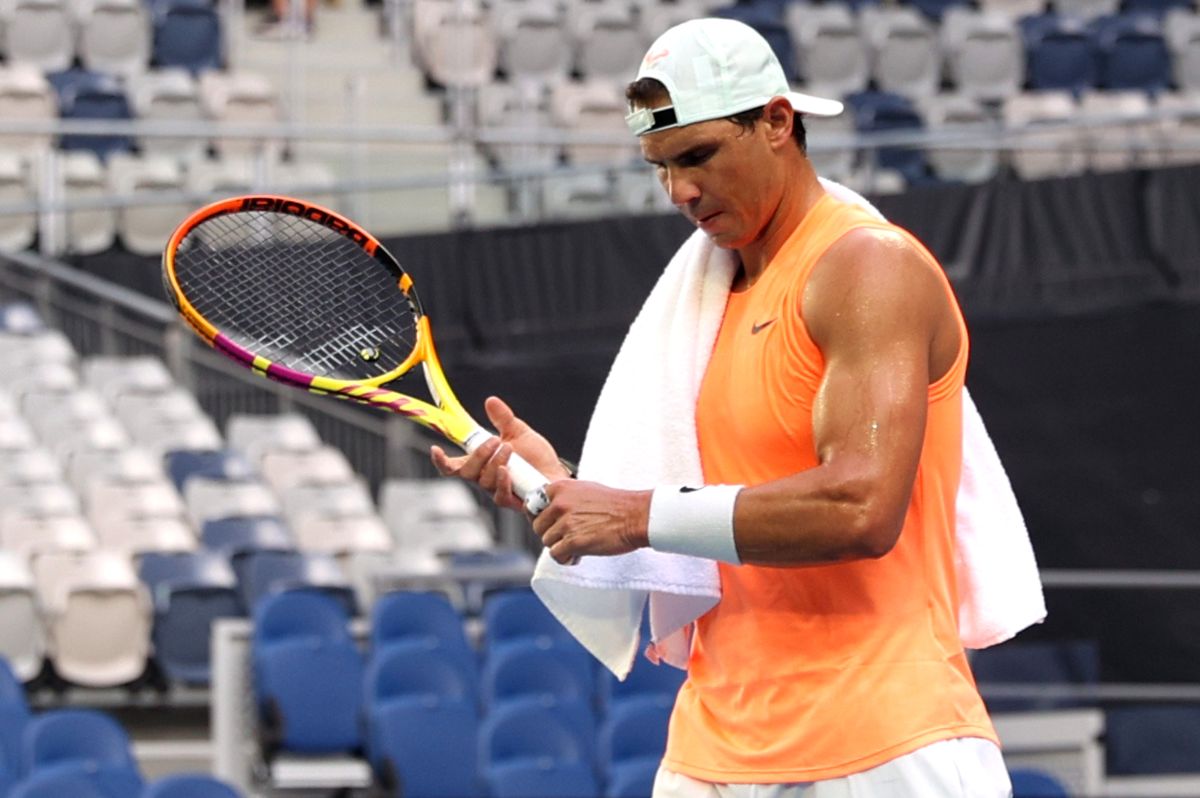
top-left (625, 18), bottom-right (842, 136)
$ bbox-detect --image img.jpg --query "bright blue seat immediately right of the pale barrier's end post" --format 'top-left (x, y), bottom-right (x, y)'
top-left (251, 592), bottom-right (365, 754)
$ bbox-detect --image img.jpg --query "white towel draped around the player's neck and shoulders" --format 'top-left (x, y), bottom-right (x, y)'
top-left (533, 179), bottom-right (1045, 679)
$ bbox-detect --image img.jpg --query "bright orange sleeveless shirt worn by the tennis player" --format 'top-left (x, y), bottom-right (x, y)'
top-left (664, 197), bottom-right (998, 784)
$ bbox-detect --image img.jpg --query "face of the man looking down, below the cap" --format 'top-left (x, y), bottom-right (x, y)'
top-left (641, 119), bottom-right (779, 248)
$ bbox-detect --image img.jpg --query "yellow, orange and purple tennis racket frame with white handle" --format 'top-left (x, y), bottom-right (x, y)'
top-left (162, 194), bottom-right (548, 515)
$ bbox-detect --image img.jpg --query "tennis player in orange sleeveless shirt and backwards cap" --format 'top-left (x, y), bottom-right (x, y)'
top-left (433, 19), bottom-right (1012, 798)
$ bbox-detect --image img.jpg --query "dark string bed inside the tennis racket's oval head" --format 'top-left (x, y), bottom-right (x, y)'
top-left (175, 205), bottom-right (416, 380)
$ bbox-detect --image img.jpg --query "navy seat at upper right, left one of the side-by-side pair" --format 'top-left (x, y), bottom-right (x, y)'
top-left (1020, 13), bottom-right (1099, 94)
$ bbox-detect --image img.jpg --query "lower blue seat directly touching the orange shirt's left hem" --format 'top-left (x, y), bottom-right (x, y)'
top-left (596, 696), bottom-right (672, 796)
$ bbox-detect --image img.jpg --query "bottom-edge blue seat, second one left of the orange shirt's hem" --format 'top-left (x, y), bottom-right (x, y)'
top-left (479, 703), bottom-right (600, 798)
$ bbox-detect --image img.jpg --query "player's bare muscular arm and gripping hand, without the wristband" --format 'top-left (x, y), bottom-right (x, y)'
top-left (534, 230), bottom-right (959, 565)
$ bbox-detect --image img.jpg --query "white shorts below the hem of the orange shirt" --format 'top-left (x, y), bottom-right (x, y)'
top-left (653, 737), bottom-right (1013, 798)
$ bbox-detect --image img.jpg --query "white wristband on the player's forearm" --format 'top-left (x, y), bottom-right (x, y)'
top-left (647, 485), bottom-right (743, 565)
